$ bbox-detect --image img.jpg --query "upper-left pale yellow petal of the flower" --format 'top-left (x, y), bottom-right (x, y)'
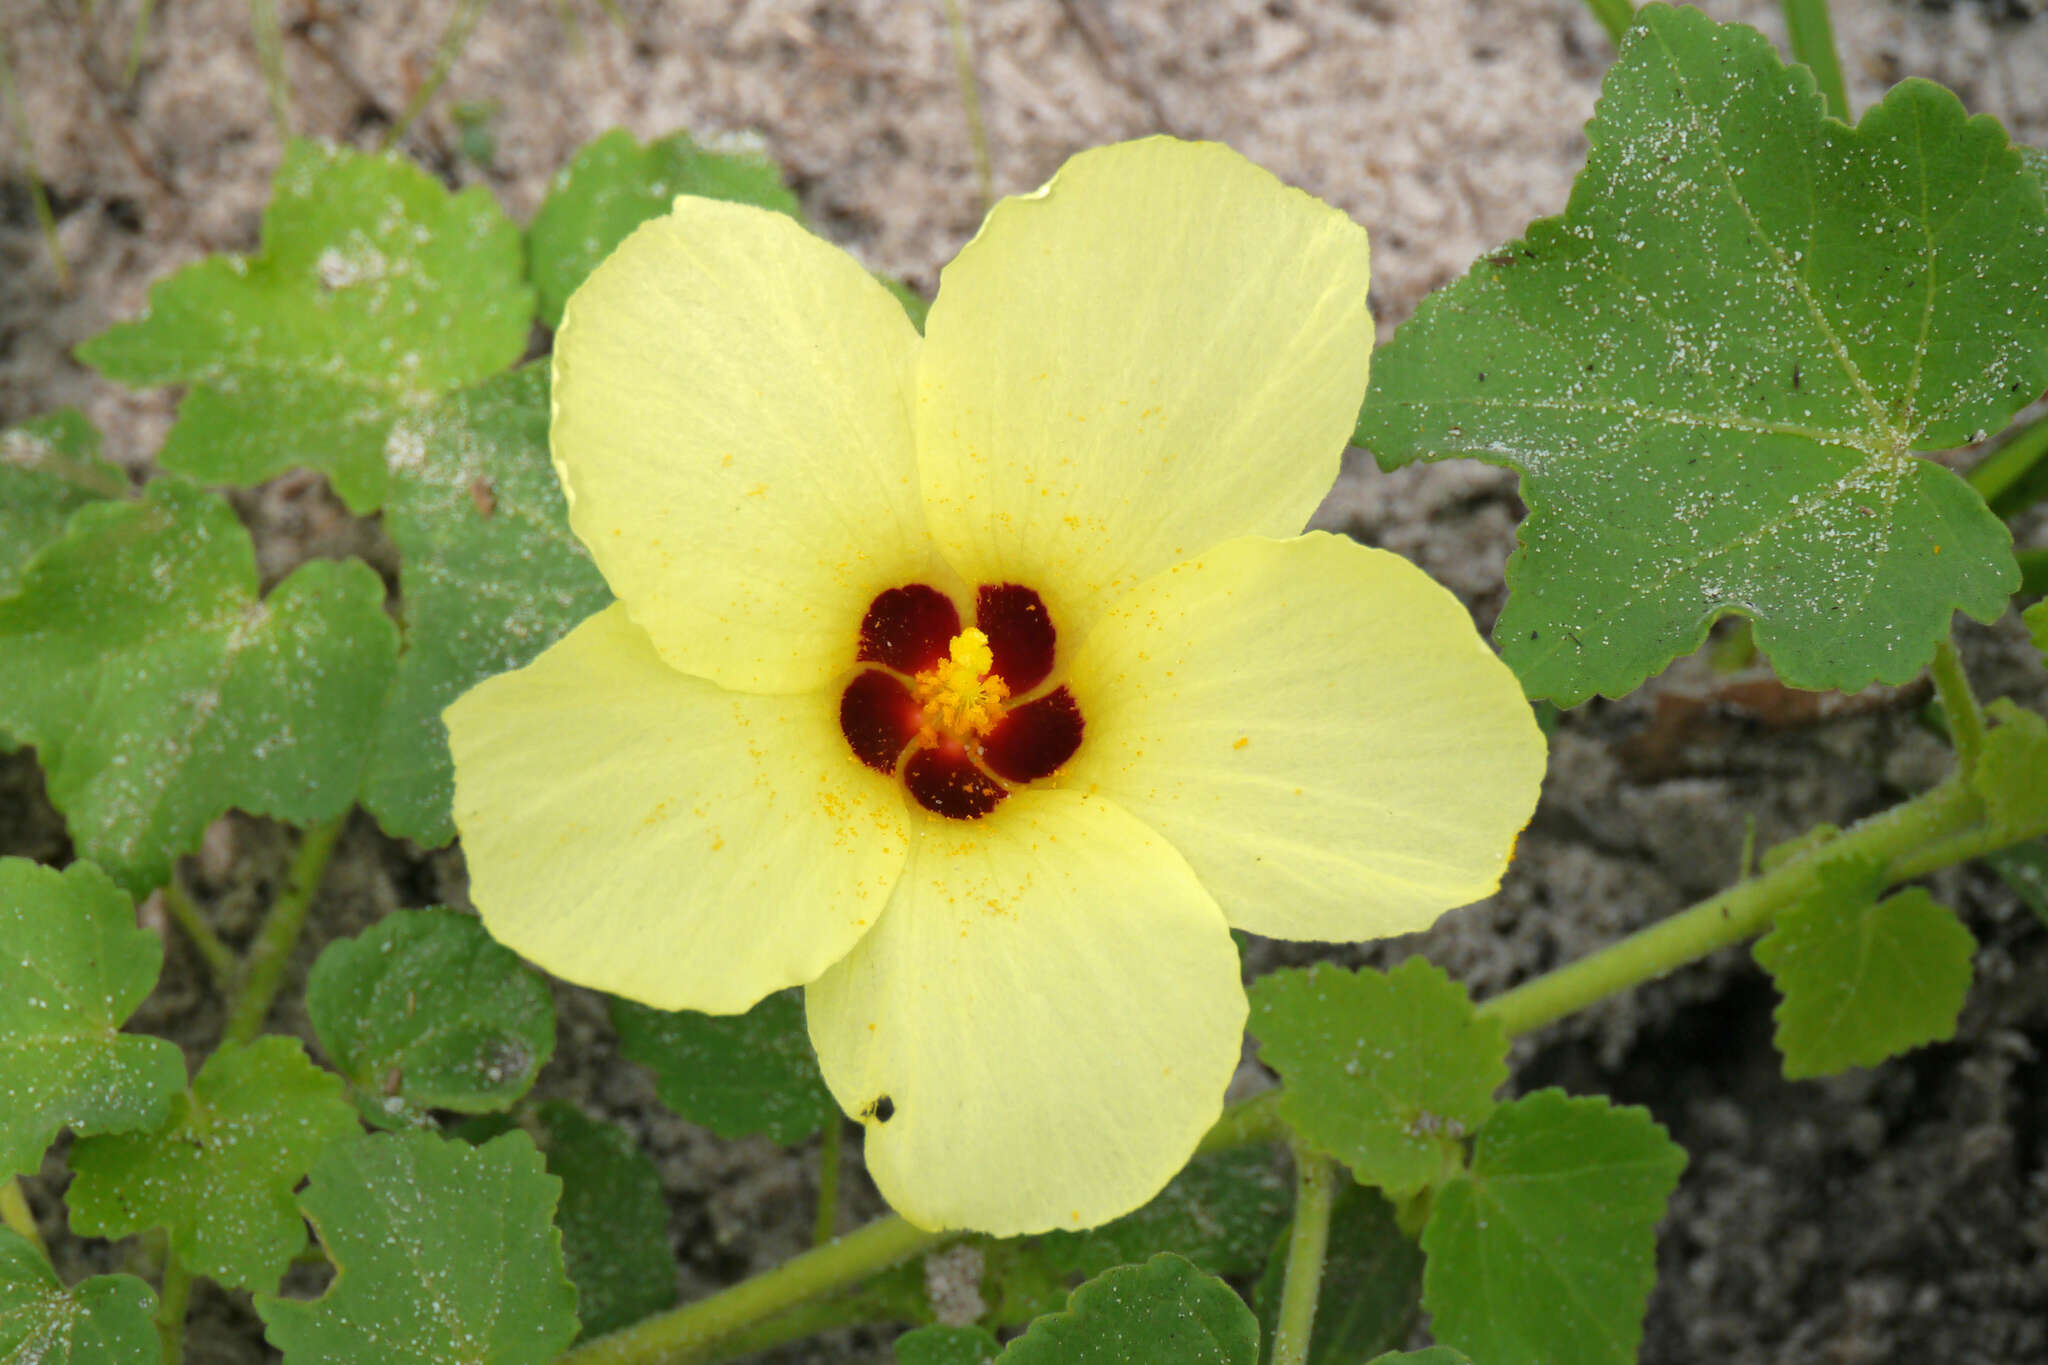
top-left (553, 196), bottom-right (930, 692)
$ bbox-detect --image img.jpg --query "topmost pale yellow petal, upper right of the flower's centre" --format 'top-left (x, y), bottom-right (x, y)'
top-left (918, 137), bottom-right (1372, 641)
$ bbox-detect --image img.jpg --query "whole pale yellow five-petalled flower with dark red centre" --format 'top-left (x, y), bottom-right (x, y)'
top-left (446, 139), bottom-right (1542, 1234)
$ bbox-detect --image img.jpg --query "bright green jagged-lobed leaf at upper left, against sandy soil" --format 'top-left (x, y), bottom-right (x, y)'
top-left (78, 141), bottom-right (532, 514)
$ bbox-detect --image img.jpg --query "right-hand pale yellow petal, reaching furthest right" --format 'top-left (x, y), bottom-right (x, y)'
top-left (1065, 534), bottom-right (1544, 939)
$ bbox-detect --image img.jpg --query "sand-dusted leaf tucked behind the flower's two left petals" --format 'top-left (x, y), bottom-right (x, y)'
top-left (362, 364), bottom-right (610, 847)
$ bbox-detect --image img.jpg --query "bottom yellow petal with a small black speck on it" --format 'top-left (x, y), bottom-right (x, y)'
top-left (805, 792), bottom-right (1245, 1236)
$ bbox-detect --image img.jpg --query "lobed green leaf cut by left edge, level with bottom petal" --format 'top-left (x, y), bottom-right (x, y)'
top-left (0, 857), bottom-right (184, 1181)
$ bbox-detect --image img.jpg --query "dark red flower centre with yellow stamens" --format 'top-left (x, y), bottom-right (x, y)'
top-left (840, 583), bottom-right (1081, 821)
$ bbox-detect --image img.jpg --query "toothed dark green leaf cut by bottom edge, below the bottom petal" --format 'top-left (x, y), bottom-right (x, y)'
top-left (997, 1254), bottom-right (1260, 1365)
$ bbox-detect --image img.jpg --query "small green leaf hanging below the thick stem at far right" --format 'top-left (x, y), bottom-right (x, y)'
top-left (1755, 864), bottom-right (1976, 1081)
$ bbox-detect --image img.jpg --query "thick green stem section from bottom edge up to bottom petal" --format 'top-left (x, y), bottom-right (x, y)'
top-left (555, 1216), bottom-right (956, 1365)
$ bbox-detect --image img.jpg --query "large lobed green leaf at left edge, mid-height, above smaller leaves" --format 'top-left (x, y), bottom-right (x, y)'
top-left (0, 479), bottom-right (397, 894)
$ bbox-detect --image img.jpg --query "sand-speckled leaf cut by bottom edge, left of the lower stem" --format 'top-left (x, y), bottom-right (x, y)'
top-left (256, 1132), bottom-right (575, 1365)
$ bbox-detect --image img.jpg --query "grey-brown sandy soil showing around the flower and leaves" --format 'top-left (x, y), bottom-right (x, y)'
top-left (0, 0), bottom-right (2048, 1365)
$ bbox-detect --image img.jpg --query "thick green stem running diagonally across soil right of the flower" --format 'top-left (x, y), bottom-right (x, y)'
top-left (1479, 778), bottom-right (1982, 1036)
